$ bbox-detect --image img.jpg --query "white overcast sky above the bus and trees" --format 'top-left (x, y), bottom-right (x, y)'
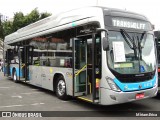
top-left (0, 0), bottom-right (160, 30)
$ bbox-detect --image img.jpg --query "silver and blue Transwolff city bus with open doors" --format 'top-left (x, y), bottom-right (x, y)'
top-left (4, 7), bottom-right (158, 105)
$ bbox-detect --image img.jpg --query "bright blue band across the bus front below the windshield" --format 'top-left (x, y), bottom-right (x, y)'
top-left (114, 76), bottom-right (156, 92)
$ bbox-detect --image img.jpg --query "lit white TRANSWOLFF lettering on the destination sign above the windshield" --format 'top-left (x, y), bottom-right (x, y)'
top-left (112, 18), bottom-right (147, 30)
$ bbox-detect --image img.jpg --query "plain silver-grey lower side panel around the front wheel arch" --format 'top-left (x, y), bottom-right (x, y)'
top-left (29, 65), bottom-right (73, 95)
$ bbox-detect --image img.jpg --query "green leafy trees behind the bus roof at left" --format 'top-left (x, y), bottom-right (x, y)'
top-left (0, 8), bottom-right (51, 39)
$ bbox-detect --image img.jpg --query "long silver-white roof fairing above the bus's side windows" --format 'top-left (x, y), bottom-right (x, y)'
top-left (5, 7), bottom-right (103, 44)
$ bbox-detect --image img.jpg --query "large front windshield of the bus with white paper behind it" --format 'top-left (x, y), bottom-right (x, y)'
top-left (107, 30), bottom-right (156, 74)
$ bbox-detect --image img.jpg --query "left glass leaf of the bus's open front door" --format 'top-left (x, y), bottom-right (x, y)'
top-left (72, 38), bottom-right (87, 96)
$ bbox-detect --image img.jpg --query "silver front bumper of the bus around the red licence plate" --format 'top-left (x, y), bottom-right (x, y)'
top-left (100, 86), bottom-right (158, 105)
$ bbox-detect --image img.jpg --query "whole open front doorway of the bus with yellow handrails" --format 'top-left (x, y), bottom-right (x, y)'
top-left (72, 34), bottom-right (101, 103)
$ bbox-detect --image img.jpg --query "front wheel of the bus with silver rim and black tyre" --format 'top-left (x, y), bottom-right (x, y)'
top-left (56, 76), bottom-right (67, 100)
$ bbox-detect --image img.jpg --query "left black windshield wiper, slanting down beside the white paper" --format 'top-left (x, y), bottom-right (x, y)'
top-left (120, 29), bottom-right (138, 59)
